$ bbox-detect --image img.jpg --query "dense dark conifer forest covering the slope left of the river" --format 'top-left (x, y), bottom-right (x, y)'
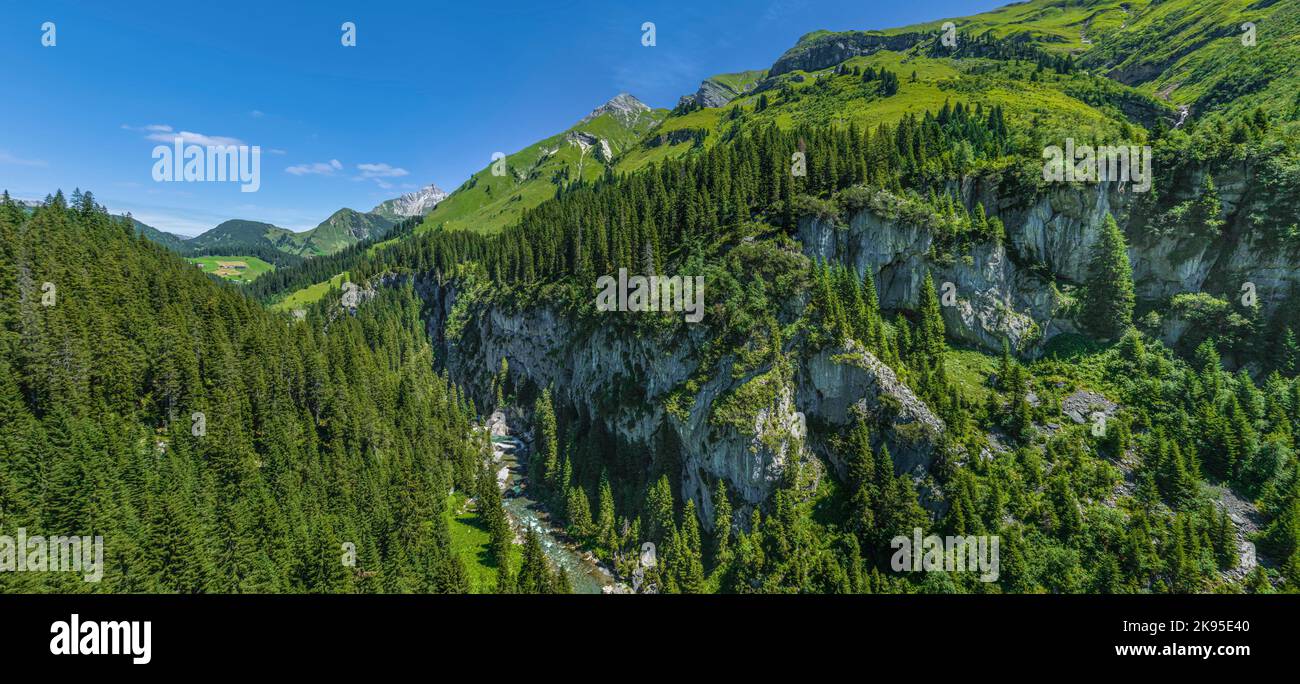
top-left (0, 192), bottom-right (574, 593)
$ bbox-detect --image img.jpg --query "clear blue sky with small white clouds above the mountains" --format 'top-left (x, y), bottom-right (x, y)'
top-left (0, 0), bottom-right (1006, 235)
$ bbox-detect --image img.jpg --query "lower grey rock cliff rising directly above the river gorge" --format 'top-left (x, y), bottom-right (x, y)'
top-left (417, 280), bottom-right (944, 528)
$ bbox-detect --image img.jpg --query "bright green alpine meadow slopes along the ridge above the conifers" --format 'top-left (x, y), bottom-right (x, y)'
top-left (266, 0), bottom-right (1268, 309)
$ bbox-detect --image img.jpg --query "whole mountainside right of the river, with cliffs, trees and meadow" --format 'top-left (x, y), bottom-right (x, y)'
top-left (241, 3), bottom-right (1300, 593)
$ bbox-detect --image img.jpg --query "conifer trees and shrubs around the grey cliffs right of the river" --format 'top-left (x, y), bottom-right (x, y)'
top-left (284, 91), bottom-right (1300, 592)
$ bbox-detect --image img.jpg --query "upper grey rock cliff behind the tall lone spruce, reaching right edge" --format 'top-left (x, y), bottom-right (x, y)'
top-left (798, 176), bottom-right (1300, 355)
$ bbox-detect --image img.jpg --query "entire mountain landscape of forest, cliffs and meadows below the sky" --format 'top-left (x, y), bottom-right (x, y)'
top-left (0, 0), bottom-right (1300, 593)
